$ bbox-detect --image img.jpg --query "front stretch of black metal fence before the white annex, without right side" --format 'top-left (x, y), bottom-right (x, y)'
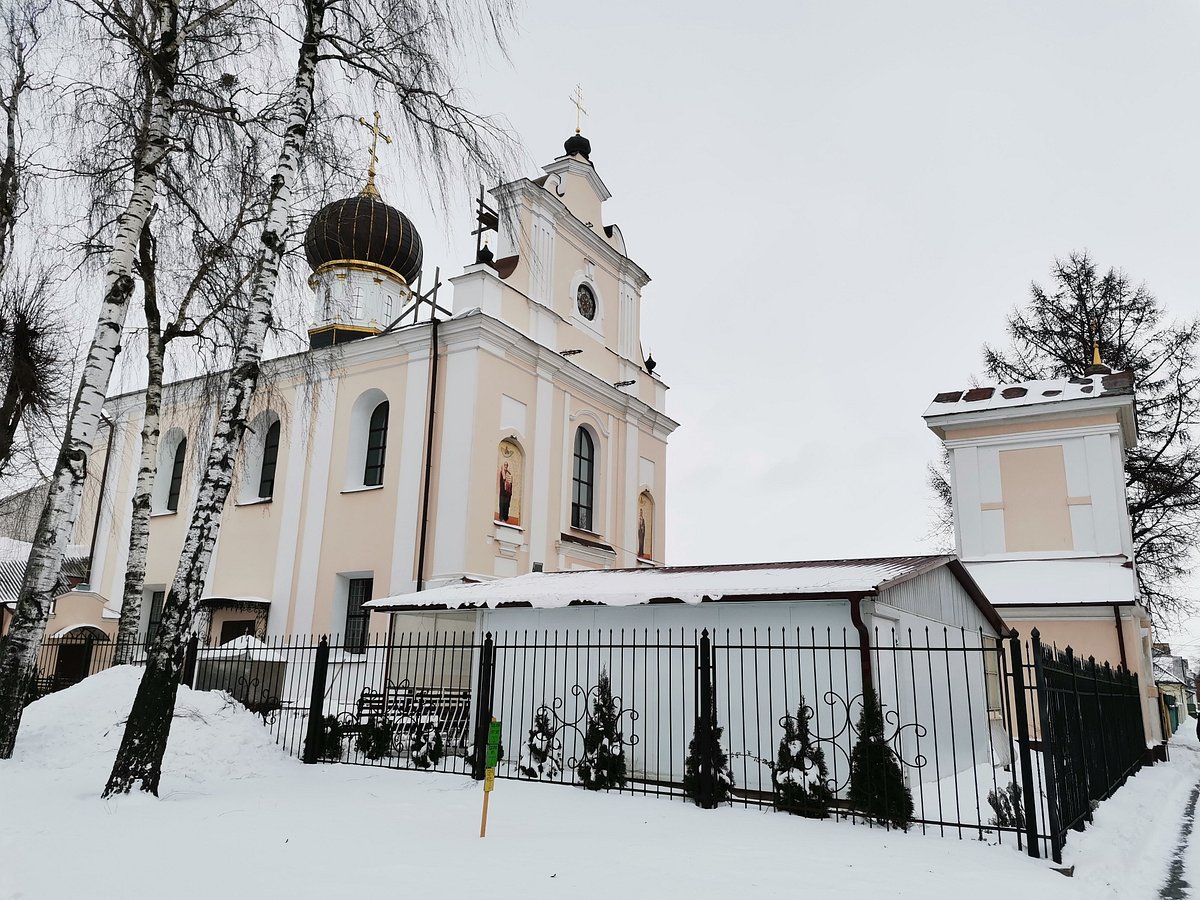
top-left (182, 629), bottom-right (1048, 846)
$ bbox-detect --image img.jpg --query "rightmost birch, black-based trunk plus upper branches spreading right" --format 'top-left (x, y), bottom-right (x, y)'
top-left (104, 0), bottom-right (511, 797)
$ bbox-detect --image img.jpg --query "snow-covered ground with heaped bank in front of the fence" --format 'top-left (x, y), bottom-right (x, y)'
top-left (0, 667), bottom-right (1200, 900)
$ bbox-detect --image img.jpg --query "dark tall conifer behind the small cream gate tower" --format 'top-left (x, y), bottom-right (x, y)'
top-left (929, 252), bottom-right (1200, 618)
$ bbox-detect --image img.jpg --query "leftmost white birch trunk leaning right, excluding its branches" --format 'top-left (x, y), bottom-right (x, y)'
top-left (0, 0), bottom-right (179, 760)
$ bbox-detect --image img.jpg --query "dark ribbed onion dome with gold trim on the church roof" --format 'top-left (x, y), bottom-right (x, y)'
top-left (304, 193), bottom-right (422, 284)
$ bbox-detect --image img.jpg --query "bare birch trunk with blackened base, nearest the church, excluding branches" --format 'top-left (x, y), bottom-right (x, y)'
top-left (103, 0), bottom-right (325, 797)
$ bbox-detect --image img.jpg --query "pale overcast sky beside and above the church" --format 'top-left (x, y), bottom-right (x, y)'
top-left (384, 0), bottom-right (1200, 633)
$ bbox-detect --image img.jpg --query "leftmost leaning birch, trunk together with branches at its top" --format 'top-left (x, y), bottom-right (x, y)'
top-left (0, 0), bottom-right (243, 758)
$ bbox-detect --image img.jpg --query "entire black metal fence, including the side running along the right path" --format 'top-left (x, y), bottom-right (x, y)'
top-left (31, 628), bottom-right (1146, 862)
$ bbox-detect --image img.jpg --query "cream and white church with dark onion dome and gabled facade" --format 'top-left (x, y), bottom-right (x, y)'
top-left (35, 134), bottom-right (677, 643)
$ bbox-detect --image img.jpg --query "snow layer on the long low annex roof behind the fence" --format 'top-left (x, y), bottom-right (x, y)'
top-left (364, 556), bottom-right (953, 611)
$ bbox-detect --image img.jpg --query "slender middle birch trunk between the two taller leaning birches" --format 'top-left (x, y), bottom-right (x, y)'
top-left (114, 332), bottom-right (163, 665)
